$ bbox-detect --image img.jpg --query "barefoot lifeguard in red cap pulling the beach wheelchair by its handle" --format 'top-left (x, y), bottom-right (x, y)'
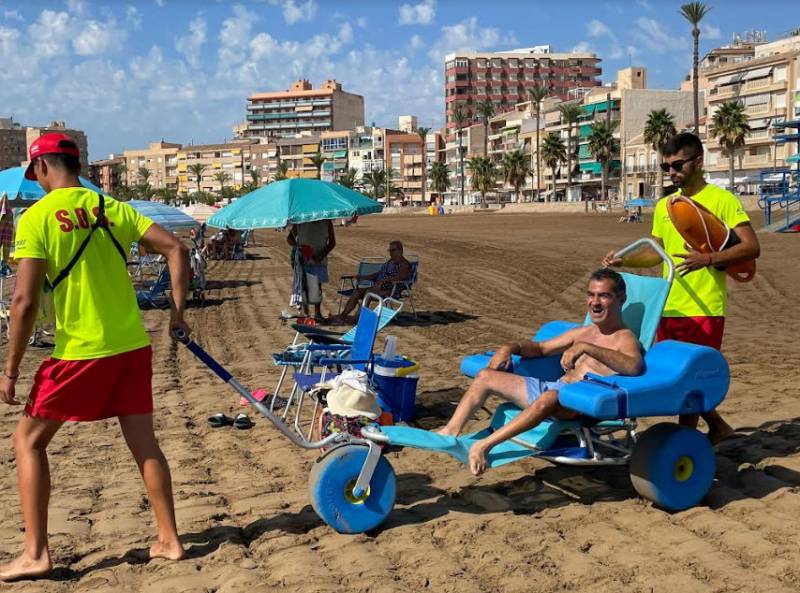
top-left (0, 134), bottom-right (189, 580)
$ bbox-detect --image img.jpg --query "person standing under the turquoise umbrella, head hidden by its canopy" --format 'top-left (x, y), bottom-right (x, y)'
top-left (286, 220), bottom-right (336, 321)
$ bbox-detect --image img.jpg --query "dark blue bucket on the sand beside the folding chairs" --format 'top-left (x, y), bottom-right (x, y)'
top-left (373, 356), bottom-right (419, 422)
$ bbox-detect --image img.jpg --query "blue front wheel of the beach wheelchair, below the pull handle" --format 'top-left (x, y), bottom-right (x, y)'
top-left (309, 445), bottom-right (397, 533)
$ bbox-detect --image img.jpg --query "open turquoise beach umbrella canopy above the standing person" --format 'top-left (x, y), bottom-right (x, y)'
top-left (208, 179), bottom-right (383, 230)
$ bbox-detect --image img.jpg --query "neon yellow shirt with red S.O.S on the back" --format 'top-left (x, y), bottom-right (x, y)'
top-left (15, 187), bottom-right (153, 360)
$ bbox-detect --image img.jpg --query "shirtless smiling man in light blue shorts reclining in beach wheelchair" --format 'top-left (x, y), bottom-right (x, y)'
top-left (438, 269), bottom-right (644, 475)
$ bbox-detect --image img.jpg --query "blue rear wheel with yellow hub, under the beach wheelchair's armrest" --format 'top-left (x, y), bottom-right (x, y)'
top-left (630, 423), bottom-right (716, 511)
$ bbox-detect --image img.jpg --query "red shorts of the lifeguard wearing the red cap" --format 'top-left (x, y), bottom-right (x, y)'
top-left (25, 346), bottom-right (153, 421)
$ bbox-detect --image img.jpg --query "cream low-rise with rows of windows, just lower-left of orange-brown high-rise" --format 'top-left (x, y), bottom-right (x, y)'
top-left (177, 139), bottom-right (253, 193)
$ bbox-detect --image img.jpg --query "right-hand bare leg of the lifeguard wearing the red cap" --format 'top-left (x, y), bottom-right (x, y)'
top-left (119, 414), bottom-right (186, 560)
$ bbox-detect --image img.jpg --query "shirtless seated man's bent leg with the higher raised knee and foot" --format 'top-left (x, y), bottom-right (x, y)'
top-left (438, 369), bottom-right (528, 436)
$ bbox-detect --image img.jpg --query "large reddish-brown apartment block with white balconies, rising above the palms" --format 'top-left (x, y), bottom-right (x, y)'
top-left (444, 45), bottom-right (602, 133)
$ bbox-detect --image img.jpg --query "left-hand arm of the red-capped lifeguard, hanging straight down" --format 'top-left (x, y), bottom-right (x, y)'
top-left (0, 258), bottom-right (47, 404)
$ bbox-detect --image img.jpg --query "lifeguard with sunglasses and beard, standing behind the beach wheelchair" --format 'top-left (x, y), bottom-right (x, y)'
top-left (603, 132), bottom-right (761, 444)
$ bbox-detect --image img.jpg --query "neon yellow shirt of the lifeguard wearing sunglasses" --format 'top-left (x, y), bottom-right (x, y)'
top-left (652, 183), bottom-right (750, 317)
